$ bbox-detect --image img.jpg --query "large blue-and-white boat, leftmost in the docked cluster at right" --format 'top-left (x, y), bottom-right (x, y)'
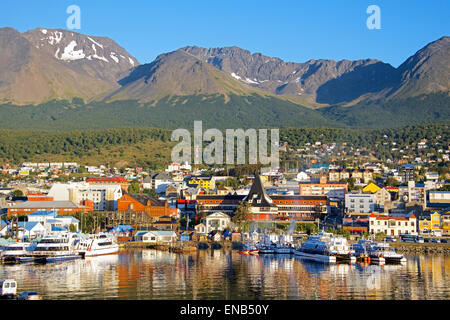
top-left (294, 232), bottom-right (336, 263)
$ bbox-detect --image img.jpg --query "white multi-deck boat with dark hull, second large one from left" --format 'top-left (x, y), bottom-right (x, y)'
top-left (33, 233), bottom-right (81, 263)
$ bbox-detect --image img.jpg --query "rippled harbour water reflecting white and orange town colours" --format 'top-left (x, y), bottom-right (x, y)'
top-left (0, 250), bottom-right (450, 300)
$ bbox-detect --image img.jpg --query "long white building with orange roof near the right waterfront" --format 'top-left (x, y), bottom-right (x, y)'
top-left (369, 214), bottom-right (417, 236)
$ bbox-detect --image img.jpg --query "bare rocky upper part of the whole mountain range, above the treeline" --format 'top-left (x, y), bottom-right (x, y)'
top-left (0, 28), bottom-right (450, 106)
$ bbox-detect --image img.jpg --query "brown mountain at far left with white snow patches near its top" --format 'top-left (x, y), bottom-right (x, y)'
top-left (0, 28), bottom-right (139, 104)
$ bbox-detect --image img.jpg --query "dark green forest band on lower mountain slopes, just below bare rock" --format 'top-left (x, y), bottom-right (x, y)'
top-left (0, 93), bottom-right (450, 131)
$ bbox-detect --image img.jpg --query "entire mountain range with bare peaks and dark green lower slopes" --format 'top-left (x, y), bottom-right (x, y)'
top-left (0, 28), bottom-right (450, 127)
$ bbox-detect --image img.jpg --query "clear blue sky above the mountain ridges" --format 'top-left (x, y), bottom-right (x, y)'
top-left (0, 0), bottom-right (450, 67)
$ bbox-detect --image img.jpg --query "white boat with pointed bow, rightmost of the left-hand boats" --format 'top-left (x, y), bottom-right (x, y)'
top-left (77, 233), bottom-right (119, 257)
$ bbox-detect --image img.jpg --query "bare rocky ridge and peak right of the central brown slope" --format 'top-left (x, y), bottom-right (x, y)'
top-left (182, 37), bottom-right (450, 104)
